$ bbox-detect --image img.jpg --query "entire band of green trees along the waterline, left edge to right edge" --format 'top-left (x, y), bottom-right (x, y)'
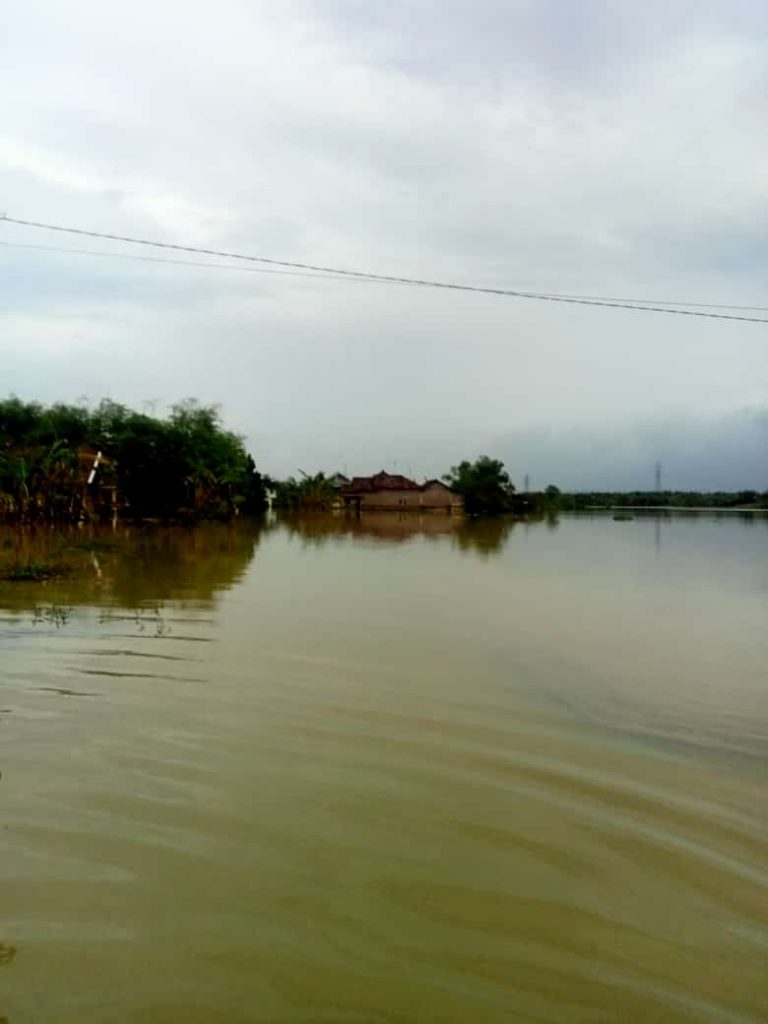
top-left (0, 397), bottom-right (768, 523)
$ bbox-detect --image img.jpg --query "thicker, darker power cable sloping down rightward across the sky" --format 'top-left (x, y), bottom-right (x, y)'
top-left (0, 214), bottom-right (768, 324)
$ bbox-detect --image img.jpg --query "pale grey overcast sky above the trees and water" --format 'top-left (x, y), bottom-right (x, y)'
top-left (0, 0), bottom-right (768, 488)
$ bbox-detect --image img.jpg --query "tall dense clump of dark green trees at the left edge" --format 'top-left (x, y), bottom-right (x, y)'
top-left (0, 397), bottom-right (266, 522)
